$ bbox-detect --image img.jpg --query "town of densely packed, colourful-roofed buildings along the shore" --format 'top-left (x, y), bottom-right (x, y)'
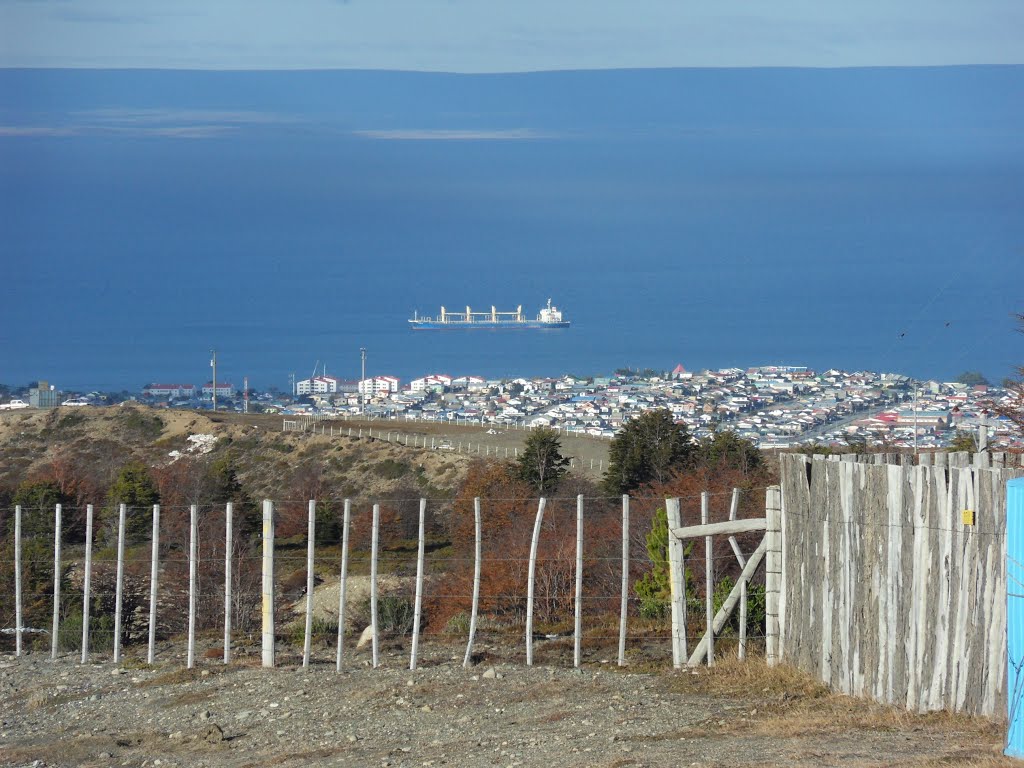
top-left (0, 365), bottom-right (1024, 451)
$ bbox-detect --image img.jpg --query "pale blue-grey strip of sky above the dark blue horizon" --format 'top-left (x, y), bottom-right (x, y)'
top-left (0, 0), bottom-right (1024, 72)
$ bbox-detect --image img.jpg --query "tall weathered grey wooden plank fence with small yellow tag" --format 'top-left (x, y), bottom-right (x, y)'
top-left (778, 454), bottom-right (1024, 715)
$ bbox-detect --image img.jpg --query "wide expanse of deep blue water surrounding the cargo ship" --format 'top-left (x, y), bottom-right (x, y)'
top-left (0, 67), bottom-right (1024, 389)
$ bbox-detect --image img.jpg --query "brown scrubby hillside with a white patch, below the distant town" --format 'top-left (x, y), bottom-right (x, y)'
top-left (0, 406), bottom-right (469, 504)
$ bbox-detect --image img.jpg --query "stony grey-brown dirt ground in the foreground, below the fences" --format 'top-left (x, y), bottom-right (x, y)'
top-left (0, 638), bottom-right (1019, 768)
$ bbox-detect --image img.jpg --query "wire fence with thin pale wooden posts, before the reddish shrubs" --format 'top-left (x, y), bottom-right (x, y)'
top-left (0, 489), bottom-right (764, 664)
